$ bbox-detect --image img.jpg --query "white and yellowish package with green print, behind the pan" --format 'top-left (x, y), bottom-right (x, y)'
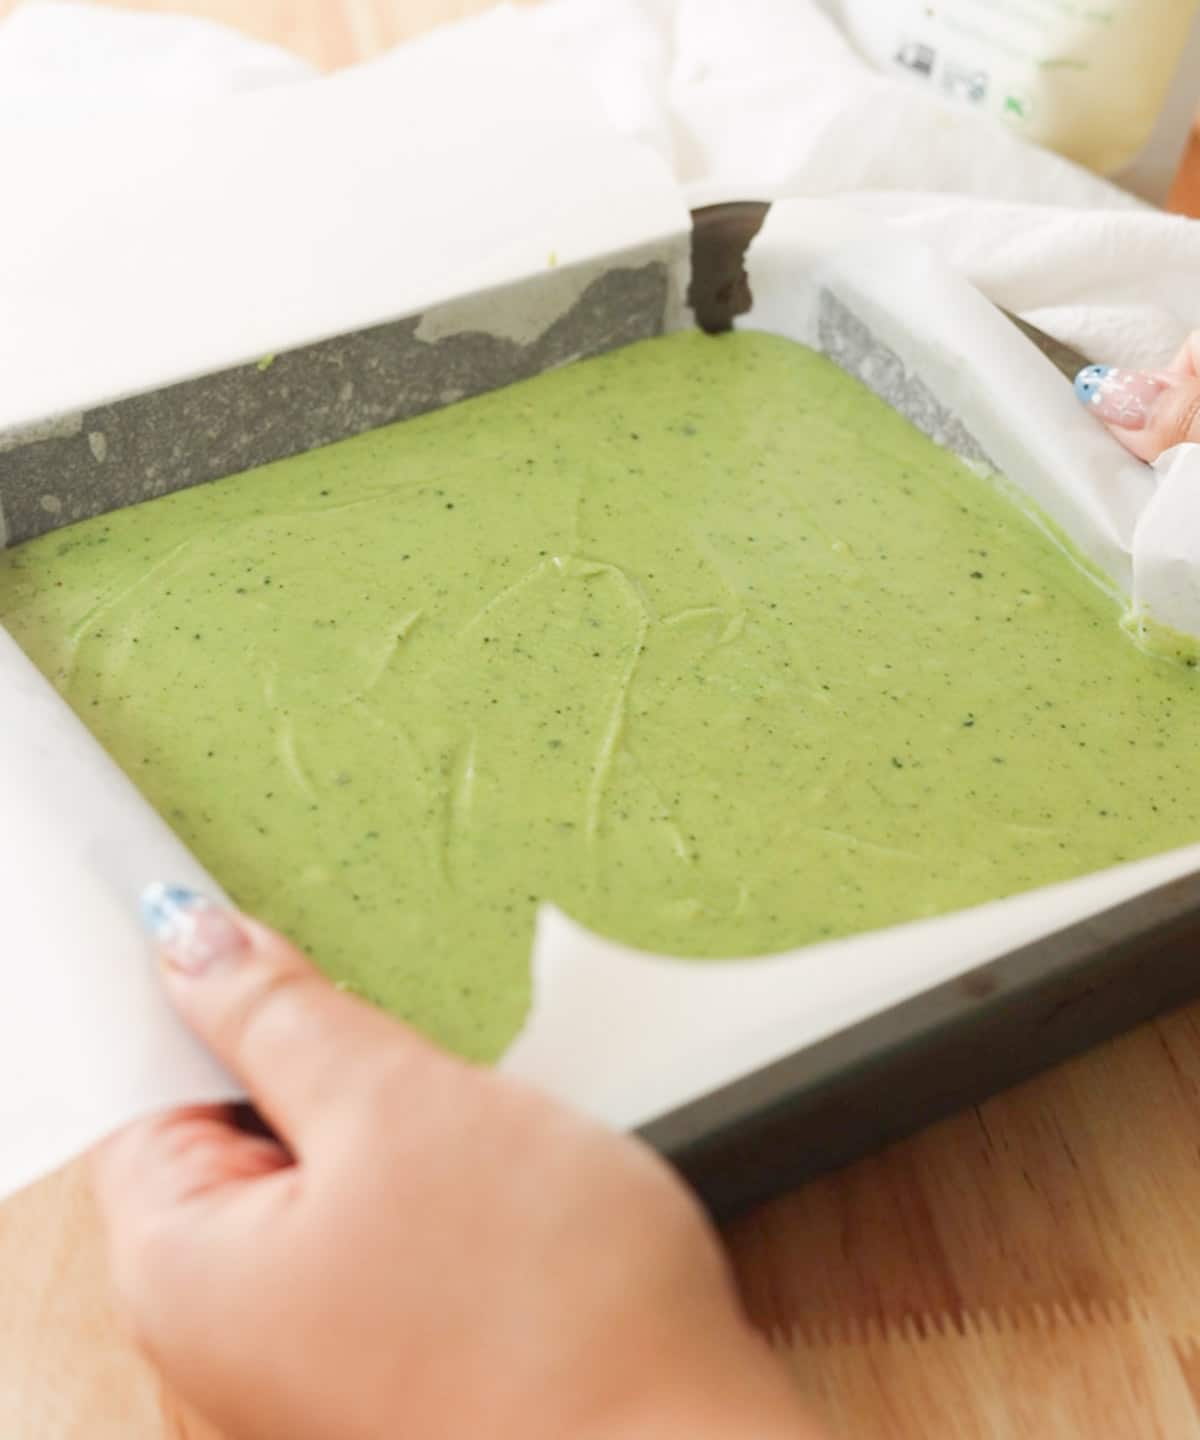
top-left (824, 0), bottom-right (1200, 203)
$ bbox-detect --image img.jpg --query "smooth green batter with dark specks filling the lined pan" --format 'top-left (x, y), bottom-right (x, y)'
top-left (0, 334), bottom-right (1200, 1057)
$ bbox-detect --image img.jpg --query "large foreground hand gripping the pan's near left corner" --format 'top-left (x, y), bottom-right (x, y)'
top-left (94, 887), bottom-right (814, 1440)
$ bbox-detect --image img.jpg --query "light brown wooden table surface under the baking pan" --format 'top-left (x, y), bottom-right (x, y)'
top-left (0, 0), bottom-right (1200, 1440)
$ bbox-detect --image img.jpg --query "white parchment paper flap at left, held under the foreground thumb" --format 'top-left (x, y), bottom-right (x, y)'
top-left (0, 629), bottom-right (236, 1194)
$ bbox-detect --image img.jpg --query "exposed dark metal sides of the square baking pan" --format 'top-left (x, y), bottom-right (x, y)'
top-left (0, 203), bottom-right (1200, 1217)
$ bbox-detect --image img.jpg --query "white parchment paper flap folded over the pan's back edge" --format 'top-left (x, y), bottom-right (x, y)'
top-left (0, 13), bottom-right (687, 432)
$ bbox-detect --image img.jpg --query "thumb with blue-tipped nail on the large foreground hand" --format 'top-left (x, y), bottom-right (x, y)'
top-left (143, 886), bottom-right (452, 1158)
